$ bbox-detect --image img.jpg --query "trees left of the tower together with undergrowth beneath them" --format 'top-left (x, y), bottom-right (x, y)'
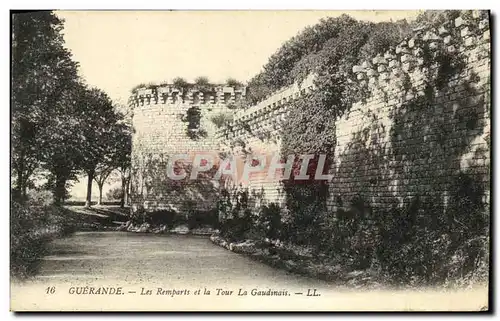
top-left (10, 11), bottom-right (136, 276)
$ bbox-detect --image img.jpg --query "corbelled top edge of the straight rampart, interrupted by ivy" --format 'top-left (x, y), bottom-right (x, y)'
top-left (217, 10), bottom-right (490, 138)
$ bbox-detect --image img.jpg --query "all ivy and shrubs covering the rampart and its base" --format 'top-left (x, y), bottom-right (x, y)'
top-left (219, 11), bottom-right (489, 284)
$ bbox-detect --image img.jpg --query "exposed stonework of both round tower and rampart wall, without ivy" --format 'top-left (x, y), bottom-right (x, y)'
top-left (131, 11), bottom-right (491, 215)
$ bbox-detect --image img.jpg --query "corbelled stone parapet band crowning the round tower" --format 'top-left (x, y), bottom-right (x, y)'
top-left (130, 84), bottom-right (246, 107)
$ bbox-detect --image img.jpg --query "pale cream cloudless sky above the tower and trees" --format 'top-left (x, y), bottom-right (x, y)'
top-left (57, 10), bottom-right (418, 103)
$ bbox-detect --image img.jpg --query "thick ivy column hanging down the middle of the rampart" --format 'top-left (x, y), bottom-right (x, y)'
top-left (278, 16), bottom-right (418, 246)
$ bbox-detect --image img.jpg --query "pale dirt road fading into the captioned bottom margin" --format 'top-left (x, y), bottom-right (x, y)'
top-left (12, 232), bottom-right (487, 310)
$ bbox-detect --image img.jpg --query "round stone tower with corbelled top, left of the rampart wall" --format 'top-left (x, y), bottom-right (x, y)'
top-left (130, 84), bottom-right (246, 213)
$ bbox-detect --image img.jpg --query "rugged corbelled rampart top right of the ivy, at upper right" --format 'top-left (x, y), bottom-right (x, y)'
top-left (352, 11), bottom-right (490, 94)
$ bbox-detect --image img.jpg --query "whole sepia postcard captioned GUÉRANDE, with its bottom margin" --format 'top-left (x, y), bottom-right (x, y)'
top-left (10, 10), bottom-right (491, 312)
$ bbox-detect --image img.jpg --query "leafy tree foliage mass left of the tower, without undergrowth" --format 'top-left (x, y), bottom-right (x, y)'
top-left (12, 11), bottom-right (131, 204)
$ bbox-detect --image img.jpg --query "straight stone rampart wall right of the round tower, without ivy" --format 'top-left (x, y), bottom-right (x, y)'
top-left (213, 11), bottom-right (490, 206)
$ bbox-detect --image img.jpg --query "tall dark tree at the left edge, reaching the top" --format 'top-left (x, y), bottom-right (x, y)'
top-left (11, 11), bottom-right (78, 198)
